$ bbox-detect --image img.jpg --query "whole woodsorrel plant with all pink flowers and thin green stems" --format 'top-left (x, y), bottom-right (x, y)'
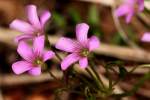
top-left (10, 0), bottom-right (150, 100)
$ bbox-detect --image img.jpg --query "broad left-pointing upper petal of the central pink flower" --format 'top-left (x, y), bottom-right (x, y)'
top-left (55, 37), bottom-right (81, 52)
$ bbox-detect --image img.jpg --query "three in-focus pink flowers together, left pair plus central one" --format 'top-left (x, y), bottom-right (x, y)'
top-left (10, 5), bottom-right (100, 75)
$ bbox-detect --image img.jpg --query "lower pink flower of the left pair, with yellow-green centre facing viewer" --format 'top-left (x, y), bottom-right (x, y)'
top-left (12, 36), bottom-right (54, 76)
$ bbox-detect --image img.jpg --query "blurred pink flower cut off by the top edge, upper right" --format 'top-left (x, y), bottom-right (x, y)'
top-left (115, 0), bottom-right (144, 23)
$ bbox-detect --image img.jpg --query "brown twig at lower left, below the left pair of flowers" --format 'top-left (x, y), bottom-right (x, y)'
top-left (0, 71), bottom-right (62, 86)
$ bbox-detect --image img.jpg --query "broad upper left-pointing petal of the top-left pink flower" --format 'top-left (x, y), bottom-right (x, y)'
top-left (10, 19), bottom-right (34, 33)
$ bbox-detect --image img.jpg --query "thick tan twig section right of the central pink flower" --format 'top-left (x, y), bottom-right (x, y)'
top-left (95, 44), bottom-right (150, 63)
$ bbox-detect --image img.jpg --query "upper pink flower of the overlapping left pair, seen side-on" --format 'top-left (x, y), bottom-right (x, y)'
top-left (10, 5), bottom-right (51, 42)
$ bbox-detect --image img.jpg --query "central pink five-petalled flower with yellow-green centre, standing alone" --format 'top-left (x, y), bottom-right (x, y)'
top-left (55, 23), bottom-right (100, 70)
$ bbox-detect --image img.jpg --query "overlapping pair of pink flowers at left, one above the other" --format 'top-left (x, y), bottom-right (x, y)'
top-left (10, 5), bottom-right (55, 75)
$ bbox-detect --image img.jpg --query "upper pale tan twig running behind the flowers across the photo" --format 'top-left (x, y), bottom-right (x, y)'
top-left (0, 28), bottom-right (150, 63)
